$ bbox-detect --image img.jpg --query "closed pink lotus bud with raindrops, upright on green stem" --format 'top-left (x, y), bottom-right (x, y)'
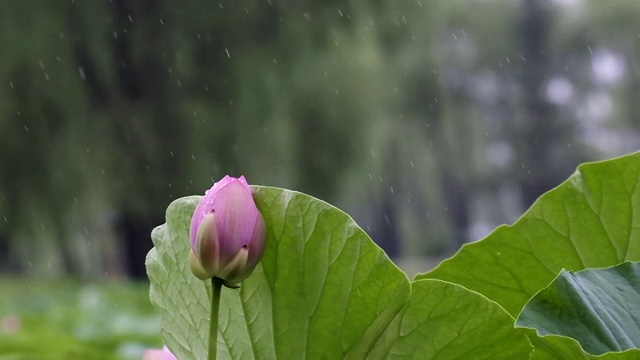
top-left (189, 175), bottom-right (266, 287)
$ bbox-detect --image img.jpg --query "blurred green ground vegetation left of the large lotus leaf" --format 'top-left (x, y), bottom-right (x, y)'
top-left (0, 277), bottom-right (162, 360)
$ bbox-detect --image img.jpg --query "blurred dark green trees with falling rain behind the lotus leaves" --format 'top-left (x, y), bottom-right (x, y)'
top-left (0, 0), bottom-right (640, 278)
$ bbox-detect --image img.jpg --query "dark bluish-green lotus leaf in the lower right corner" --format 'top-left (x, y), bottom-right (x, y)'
top-left (516, 263), bottom-right (640, 355)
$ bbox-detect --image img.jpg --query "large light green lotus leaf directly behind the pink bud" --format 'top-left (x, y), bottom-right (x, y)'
top-left (147, 187), bottom-right (531, 359)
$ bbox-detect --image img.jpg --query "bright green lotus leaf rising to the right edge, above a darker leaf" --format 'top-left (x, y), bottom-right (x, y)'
top-left (416, 153), bottom-right (640, 317)
